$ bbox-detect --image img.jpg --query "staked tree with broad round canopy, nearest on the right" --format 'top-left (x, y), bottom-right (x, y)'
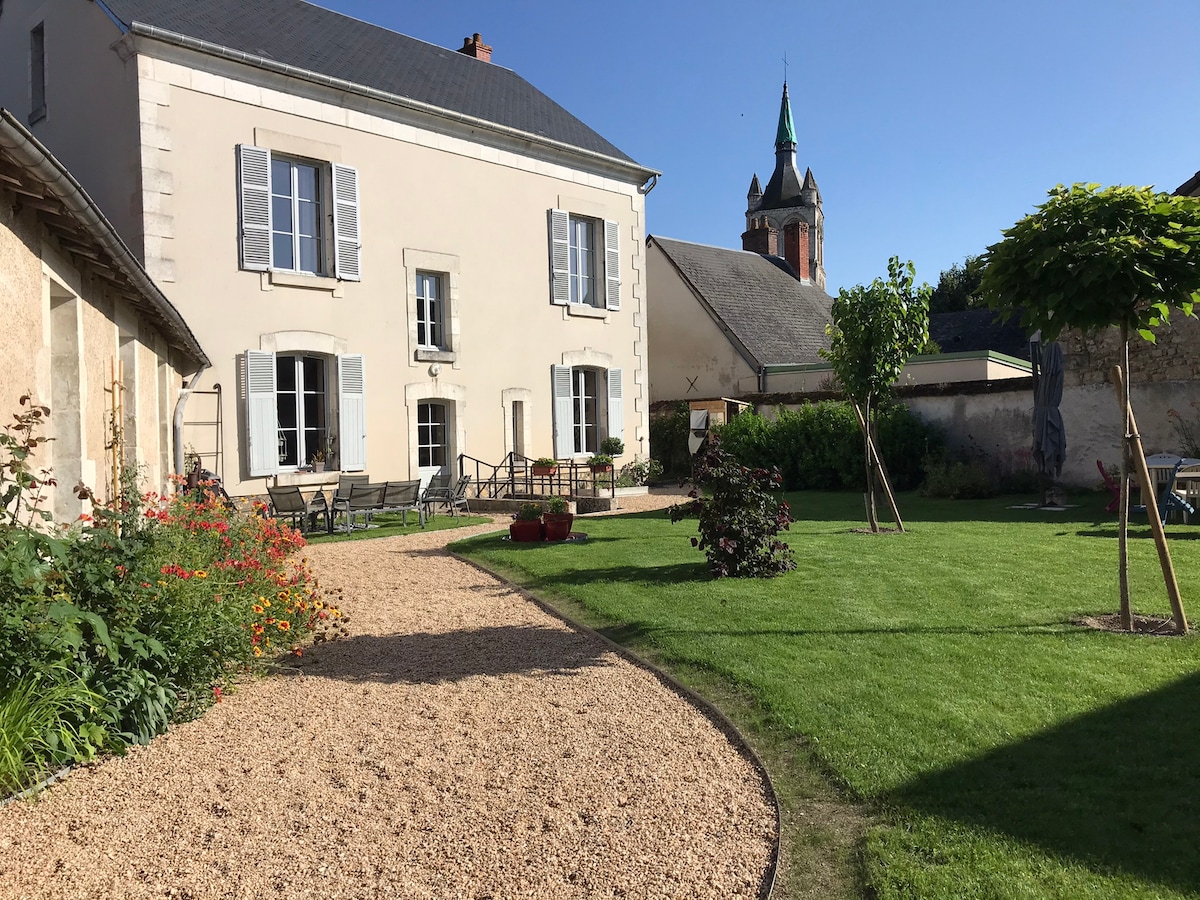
top-left (982, 185), bottom-right (1200, 631)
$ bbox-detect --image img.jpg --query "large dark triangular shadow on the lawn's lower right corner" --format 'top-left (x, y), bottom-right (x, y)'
top-left (884, 674), bottom-right (1200, 894)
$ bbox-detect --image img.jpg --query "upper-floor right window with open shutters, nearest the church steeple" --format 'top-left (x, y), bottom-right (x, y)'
top-left (550, 209), bottom-right (620, 311)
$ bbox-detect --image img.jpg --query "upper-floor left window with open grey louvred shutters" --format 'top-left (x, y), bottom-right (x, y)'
top-left (238, 144), bottom-right (361, 281)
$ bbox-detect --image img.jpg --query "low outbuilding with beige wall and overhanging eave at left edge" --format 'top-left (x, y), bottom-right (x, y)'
top-left (0, 108), bottom-right (209, 522)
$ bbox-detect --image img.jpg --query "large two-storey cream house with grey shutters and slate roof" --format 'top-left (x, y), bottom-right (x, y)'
top-left (0, 0), bottom-right (656, 494)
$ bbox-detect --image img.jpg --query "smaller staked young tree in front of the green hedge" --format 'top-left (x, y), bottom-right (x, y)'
top-left (821, 257), bottom-right (932, 532)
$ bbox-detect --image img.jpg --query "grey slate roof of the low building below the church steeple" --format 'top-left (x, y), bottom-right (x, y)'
top-left (647, 236), bottom-right (833, 366)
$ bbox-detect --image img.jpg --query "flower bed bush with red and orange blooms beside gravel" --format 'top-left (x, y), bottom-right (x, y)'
top-left (0, 407), bottom-right (348, 792)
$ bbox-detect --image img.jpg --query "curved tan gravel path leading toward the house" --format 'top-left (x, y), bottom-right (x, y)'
top-left (0, 498), bottom-right (775, 900)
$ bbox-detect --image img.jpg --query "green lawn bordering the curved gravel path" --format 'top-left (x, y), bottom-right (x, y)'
top-left (454, 492), bottom-right (1200, 898)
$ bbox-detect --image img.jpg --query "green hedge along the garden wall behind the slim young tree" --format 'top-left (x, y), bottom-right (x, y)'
top-left (716, 401), bottom-right (943, 491)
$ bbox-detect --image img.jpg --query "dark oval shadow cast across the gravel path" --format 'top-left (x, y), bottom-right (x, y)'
top-left (290, 625), bottom-right (608, 684)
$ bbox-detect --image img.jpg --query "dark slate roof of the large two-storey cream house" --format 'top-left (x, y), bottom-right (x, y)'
top-left (100, 0), bottom-right (637, 166)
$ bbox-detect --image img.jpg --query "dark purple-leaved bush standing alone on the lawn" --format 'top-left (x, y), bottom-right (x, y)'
top-left (671, 436), bottom-right (796, 578)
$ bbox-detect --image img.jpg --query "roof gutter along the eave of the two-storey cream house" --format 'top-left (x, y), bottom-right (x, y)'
top-left (127, 22), bottom-right (662, 184)
